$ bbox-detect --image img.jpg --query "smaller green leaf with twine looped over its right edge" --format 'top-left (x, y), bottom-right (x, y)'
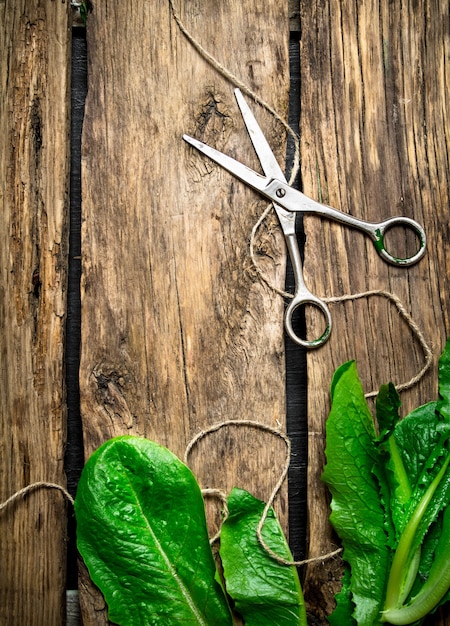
top-left (220, 489), bottom-right (306, 626)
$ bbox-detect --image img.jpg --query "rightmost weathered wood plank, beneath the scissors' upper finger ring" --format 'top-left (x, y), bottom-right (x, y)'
top-left (300, 0), bottom-right (450, 624)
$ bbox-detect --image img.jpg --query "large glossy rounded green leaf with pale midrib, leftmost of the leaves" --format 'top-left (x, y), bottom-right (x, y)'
top-left (75, 437), bottom-right (232, 626)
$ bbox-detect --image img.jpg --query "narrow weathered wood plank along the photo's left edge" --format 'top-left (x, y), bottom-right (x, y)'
top-left (0, 0), bottom-right (70, 626)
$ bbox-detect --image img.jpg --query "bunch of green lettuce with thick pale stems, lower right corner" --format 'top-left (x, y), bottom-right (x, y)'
top-left (323, 340), bottom-right (450, 626)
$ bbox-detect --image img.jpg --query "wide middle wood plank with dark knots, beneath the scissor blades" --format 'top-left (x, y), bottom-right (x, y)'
top-left (80, 0), bottom-right (289, 624)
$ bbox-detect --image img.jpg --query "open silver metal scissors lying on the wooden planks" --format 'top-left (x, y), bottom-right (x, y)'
top-left (183, 89), bottom-right (426, 348)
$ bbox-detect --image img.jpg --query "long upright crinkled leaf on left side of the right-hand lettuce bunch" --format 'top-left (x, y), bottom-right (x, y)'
top-left (322, 362), bottom-right (390, 626)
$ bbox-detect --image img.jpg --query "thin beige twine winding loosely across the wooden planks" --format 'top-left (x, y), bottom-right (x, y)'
top-left (0, 0), bottom-right (433, 566)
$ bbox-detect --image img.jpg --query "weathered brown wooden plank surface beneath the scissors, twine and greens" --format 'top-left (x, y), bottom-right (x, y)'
top-left (0, 0), bottom-right (450, 626)
